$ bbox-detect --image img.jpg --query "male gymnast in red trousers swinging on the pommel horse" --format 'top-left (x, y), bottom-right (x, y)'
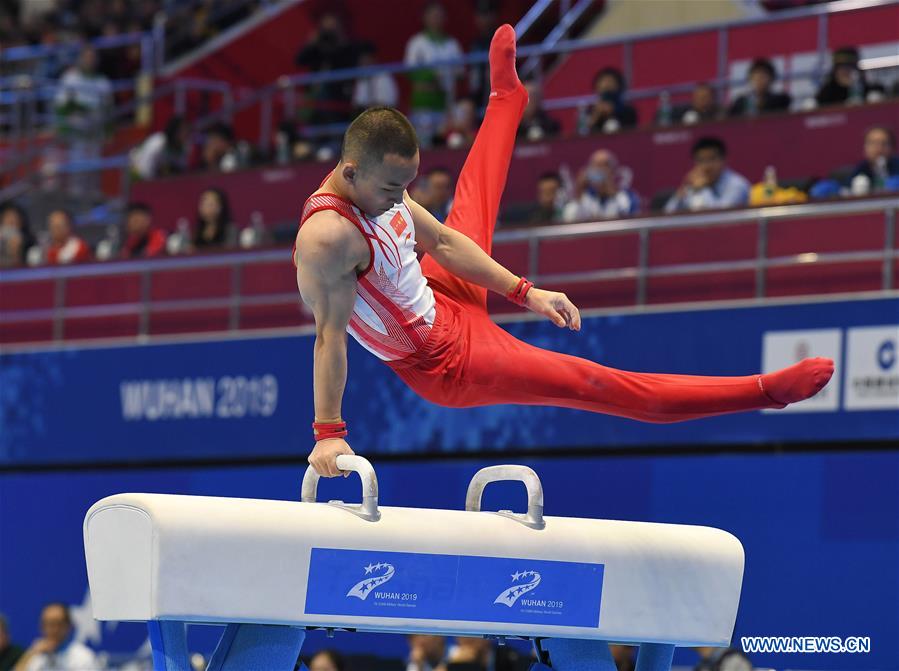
top-left (293, 25), bottom-right (834, 477)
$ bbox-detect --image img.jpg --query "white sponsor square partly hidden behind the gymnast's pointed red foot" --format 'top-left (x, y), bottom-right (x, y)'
top-left (762, 329), bottom-right (843, 412)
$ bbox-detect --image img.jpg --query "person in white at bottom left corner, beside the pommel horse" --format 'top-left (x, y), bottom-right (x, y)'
top-left (13, 603), bottom-right (100, 671)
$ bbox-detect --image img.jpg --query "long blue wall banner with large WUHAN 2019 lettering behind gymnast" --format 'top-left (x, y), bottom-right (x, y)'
top-left (0, 298), bottom-right (899, 466)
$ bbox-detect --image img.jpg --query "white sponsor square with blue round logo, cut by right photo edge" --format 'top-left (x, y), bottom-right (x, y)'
top-left (844, 325), bottom-right (899, 410)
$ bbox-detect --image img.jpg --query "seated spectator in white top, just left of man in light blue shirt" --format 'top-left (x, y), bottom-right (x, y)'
top-left (562, 149), bottom-right (640, 223)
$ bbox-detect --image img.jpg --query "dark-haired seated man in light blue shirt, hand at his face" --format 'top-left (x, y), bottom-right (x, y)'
top-left (665, 137), bottom-right (749, 213)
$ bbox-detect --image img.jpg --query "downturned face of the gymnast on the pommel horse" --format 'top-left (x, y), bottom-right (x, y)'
top-left (341, 152), bottom-right (418, 217)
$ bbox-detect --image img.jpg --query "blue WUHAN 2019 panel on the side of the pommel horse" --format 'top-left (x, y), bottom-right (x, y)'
top-left (306, 548), bottom-right (603, 627)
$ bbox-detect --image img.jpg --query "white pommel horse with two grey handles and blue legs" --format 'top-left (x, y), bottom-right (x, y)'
top-left (84, 456), bottom-right (743, 671)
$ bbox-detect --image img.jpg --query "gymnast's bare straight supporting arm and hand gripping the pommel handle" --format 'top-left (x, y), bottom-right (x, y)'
top-left (295, 210), bottom-right (369, 477)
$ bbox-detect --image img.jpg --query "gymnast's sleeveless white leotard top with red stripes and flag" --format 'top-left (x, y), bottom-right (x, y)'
top-left (300, 193), bottom-right (436, 361)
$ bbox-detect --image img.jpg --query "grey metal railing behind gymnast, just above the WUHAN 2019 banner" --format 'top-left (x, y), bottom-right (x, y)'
top-left (0, 196), bottom-right (899, 340)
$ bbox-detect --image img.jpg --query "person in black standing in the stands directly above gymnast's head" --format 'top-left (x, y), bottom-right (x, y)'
top-left (294, 11), bottom-right (356, 124)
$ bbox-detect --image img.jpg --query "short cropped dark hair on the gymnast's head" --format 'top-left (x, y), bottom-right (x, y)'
top-left (340, 107), bottom-right (418, 167)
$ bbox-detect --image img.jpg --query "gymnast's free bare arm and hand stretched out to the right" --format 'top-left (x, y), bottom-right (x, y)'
top-left (404, 194), bottom-right (581, 331)
